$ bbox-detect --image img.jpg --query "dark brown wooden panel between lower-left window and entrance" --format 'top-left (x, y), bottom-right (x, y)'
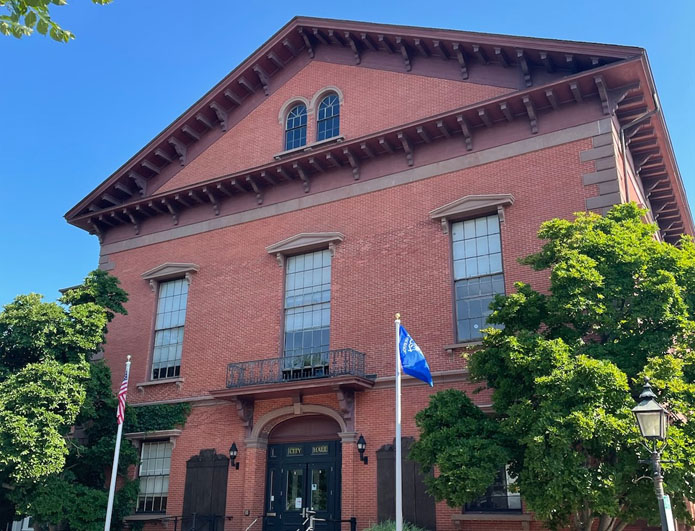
top-left (182, 449), bottom-right (229, 531)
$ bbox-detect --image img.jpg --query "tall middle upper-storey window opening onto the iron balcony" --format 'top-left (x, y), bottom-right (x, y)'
top-left (284, 249), bottom-right (331, 368)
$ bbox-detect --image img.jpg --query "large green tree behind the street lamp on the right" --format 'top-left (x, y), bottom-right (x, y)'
top-left (411, 204), bottom-right (695, 531)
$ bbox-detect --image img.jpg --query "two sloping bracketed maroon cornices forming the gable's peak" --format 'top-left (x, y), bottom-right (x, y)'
top-left (66, 17), bottom-right (644, 222)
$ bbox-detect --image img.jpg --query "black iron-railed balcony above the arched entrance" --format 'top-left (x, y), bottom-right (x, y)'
top-left (211, 348), bottom-right (374, 399)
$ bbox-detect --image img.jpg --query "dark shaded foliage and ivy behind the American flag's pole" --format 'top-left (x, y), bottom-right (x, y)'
top-left (9, 358), bottom-right (190, 531)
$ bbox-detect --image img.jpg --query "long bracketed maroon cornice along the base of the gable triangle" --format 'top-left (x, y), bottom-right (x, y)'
top-left (66, 58), bottom-right (640, 232)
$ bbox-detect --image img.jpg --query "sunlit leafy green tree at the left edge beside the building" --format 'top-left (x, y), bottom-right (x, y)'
top-left (0, 271), bottom-right (127, 519)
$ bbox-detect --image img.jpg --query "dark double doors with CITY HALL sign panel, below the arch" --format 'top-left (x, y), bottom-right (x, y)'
top-left (264, 441), bottom-right (341, 531)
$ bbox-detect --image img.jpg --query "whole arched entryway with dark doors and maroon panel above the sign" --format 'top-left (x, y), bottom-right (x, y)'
top-left (264, 415), bottom-right (342, 531)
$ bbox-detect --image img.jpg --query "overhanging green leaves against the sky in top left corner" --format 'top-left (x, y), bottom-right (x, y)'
top-left (0, 0), bottom-right (112, 42)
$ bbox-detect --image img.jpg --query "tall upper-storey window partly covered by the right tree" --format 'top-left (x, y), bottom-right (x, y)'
top-left (451, 214), bottom-right (504, 341)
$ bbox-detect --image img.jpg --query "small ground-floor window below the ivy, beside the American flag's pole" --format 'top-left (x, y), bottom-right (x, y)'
top-left (137, 441), bottom-right (172, 513)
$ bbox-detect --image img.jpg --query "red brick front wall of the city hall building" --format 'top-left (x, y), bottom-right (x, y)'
top-left (67, 15), bottom-right (692, 531)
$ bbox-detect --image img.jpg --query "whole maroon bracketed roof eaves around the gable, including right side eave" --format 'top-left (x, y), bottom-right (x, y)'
top-left (66, 17), bottom-right (692, 244)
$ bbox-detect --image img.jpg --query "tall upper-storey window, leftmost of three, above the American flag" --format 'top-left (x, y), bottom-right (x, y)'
top-left (152, 278), bottom-right (188, 380)
